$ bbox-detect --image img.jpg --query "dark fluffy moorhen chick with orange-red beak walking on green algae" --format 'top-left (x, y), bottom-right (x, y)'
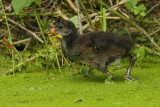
top-left (51, 20), bottom-right (135, 81)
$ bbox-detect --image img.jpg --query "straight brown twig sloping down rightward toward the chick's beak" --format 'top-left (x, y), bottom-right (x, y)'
top-left (8, 18), bottom-right (44, 43)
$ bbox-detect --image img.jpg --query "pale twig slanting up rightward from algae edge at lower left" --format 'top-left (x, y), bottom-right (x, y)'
top-left (1, 56), bottom-right (38, 76)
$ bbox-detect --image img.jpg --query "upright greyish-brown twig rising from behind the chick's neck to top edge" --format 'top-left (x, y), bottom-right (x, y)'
top-left (76, 0), bottom-right (83, 35)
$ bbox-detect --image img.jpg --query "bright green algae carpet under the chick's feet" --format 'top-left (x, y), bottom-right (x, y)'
top-left (0, 54), bottom-right (160, 107)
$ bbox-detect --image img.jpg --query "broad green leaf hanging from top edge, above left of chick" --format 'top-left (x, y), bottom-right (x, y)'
top-left (11, 0), bottom-right (41, 14)
